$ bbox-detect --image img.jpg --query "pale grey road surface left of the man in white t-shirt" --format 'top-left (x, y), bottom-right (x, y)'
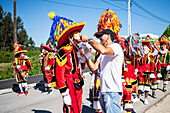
top-left (0, 73), bottom-right (94, 113)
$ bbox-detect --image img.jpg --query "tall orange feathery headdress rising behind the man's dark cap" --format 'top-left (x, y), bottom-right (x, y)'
top-left (97, 9), bottom-right (122, 36)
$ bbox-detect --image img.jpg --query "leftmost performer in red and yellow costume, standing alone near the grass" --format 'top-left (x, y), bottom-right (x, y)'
top-left (13, 41), bottom-right (31, 96)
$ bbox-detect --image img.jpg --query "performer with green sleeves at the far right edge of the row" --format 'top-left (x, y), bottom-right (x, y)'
top-left (158, 35), bottom-right (170, 92)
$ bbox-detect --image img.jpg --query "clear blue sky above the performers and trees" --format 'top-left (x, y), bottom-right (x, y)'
top-left (0, 0), bottom-right (170, 47)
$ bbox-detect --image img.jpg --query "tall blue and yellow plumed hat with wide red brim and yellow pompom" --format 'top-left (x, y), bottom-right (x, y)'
top-left (48, 12), bottom-right (86, 47)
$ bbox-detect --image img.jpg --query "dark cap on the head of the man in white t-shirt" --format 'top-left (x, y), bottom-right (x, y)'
top-left (94, 29), bottom-right (115, 41)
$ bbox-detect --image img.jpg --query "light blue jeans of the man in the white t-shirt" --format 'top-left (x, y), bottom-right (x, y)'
top-left (100, 92), bottom-right (122, 113)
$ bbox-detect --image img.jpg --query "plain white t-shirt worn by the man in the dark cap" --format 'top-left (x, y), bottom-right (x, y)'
top-left (97, 43), bottom-right (123, 92)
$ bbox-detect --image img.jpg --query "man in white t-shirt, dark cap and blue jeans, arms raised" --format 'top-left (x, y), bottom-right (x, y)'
top-left (80, 29), bottom-right (123, 113)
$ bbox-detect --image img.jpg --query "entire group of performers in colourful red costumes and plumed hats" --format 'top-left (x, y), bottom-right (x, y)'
top-left (13, 9), bottom-right (170, 113)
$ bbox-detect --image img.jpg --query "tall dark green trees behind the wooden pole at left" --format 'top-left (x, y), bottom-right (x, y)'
top-left (0, 4), bottom-right (35, 51)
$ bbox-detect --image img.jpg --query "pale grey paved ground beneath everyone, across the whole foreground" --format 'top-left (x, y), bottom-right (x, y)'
top-left (0, 70), bottom-right (170, 113)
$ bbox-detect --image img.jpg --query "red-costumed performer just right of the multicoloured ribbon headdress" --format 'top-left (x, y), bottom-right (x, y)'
top-left (137, 40), bottom-right (155, 104)
